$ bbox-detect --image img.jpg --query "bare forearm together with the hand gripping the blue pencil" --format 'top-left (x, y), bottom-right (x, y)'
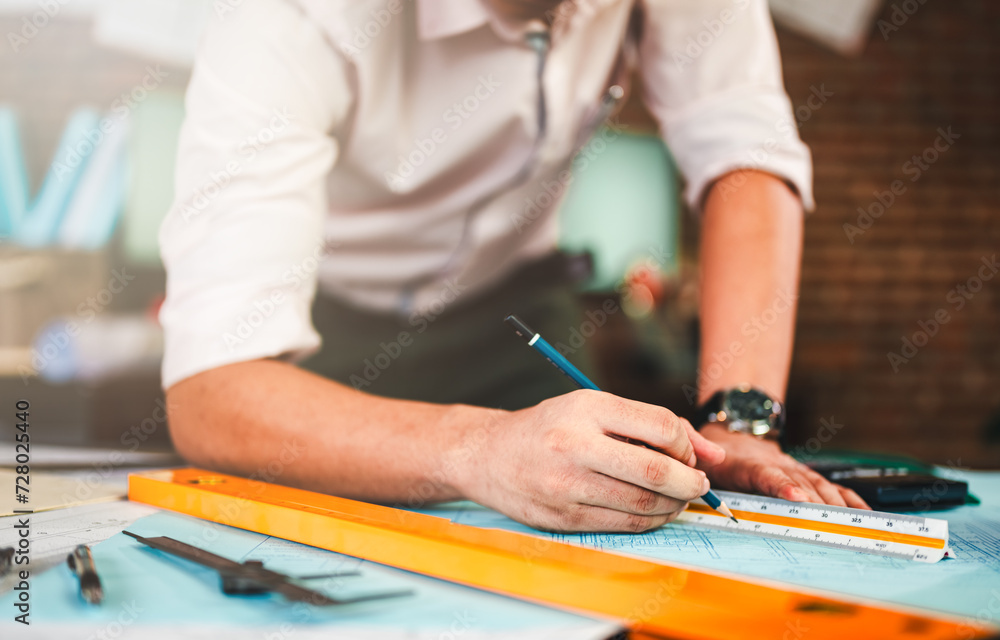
top-left (167, 360), bottom-right (736, 531)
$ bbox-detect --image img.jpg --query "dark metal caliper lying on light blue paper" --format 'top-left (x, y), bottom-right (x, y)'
top-left (122, 531), bottom-right (413, 606)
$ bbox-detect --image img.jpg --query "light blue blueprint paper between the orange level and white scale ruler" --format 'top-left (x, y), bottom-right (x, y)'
top-left (414, 472), bottom-right (1000, 624)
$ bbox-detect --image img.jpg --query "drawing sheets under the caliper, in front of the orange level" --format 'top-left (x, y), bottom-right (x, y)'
top-left (0, 503), bottom-right (618, 640)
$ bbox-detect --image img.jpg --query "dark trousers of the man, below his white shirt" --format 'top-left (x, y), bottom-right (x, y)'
top-left (302, 254), bottom-right (592, 410)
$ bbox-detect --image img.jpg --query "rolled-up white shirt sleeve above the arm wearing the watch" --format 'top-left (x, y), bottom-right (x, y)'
top-left (639, 0), bottom-right (814, 211)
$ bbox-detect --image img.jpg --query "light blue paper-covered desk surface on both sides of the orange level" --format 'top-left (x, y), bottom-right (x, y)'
top-left (0, 472), bottom-right (1000, 640)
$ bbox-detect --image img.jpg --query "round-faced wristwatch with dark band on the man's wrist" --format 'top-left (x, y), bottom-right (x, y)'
top-left (691, 384), bottom-right (785, 440)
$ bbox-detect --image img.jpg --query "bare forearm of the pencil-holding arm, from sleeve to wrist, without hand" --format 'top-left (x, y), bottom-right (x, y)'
top-left (167, 360), bottom-right (495, 503)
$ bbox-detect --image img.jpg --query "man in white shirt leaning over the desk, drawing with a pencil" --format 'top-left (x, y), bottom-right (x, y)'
top-left (161, 0), bottom-right (864, 531)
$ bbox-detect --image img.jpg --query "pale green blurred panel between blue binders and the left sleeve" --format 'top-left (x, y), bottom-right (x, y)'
top-left (123, 89), bottom-right (184, 265)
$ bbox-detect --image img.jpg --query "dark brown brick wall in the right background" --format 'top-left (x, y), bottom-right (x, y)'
top-left (768, 0), bottom-right (1000, 467)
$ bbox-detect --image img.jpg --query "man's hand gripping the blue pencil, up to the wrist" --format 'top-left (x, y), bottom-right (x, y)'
top-left (456, 391), bottom-right (725, 532)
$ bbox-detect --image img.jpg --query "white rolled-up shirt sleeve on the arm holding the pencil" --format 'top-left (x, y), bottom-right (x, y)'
top-left (160, 0), bottom-right (351, 388)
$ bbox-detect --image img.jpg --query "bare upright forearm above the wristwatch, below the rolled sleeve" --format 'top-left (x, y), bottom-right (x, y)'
top-left (698, 171), bottom-right (803, 402)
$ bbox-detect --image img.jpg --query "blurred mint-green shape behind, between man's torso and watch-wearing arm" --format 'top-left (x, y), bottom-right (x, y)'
top-left (559, 128), bottom-right (681, 291)
